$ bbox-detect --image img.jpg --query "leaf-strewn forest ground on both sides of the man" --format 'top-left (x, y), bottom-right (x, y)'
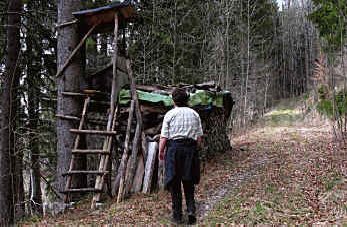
top-left (22, 103), bottom-right (347, 226)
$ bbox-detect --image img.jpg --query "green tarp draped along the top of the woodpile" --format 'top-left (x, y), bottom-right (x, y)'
top-left (119, 89), bottom-right (229, 107)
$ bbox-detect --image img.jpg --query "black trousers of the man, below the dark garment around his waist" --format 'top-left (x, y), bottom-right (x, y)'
top-left (170, 150), bottom-right (195, 219)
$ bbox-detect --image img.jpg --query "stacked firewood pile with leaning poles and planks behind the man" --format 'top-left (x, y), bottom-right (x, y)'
top-left (81, 80), bottom-right (233, 202)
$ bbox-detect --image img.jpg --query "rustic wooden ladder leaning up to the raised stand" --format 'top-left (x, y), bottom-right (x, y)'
top-left (63, 93), bottom-right (117, 207)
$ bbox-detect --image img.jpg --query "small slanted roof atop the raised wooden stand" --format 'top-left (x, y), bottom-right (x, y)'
top-left (72, 2), bottom-right (136, 33)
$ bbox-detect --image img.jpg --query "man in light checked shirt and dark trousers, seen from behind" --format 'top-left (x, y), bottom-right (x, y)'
top-left (159, 88), bottom-right (203, 224)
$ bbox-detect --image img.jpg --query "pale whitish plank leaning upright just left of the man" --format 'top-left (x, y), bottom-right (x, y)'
top-left (142, 142), bottom-right (159, 193)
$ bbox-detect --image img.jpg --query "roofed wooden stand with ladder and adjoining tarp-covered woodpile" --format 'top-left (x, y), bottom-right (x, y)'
top-left (56, 2), bottom-right (234, 208)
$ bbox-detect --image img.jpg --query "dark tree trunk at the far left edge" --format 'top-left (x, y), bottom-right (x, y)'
top-left (0, 0), bottom-right (22, 223)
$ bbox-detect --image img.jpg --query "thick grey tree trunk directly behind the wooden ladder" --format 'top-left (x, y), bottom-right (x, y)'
top-left (56, 0), bottom-right (87, 199)
